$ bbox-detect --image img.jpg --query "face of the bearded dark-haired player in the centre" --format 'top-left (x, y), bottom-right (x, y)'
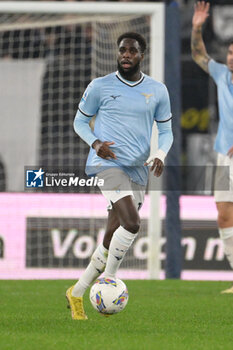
top-left (117, 38), bottom-right (144, 75)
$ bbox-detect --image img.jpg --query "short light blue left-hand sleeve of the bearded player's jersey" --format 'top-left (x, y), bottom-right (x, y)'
top-left (78, 79), bottom-right (100, 117)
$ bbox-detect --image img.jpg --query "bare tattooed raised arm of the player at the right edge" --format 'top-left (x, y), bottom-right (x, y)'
top-left (191, 1), bottom-right (210, 73)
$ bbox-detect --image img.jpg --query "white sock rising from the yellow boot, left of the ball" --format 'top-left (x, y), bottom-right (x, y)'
top-left (72, 243), bottom-right (108, 297)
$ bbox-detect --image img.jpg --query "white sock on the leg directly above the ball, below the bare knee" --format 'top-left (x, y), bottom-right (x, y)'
top-left (104, 226), bottom-right (137, 278)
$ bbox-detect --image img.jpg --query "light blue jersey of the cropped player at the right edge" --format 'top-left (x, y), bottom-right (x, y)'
top-left (208, 60), bottom-right (233, 154)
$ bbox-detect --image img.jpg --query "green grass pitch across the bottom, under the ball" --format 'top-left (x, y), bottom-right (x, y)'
top-left (0, 280), bottom-right (233, 350)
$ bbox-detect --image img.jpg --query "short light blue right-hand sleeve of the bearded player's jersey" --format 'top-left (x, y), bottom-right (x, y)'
top-left (154, 84), bottom-right (172, 123)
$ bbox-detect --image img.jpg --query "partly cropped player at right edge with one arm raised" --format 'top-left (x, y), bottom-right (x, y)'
top-left (191, 1), bottom-right (233, 293)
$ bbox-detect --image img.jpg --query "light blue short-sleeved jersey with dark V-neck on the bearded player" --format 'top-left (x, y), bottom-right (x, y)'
top-left (79, 72), bottom-right (171, 185)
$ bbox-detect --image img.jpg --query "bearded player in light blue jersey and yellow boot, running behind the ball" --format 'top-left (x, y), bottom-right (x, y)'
top-left (66, 32), bottom-right (173, 320)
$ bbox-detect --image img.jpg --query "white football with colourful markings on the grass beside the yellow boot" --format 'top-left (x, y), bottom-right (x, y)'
top-left (90, 278), bottom-right (129, 315)
